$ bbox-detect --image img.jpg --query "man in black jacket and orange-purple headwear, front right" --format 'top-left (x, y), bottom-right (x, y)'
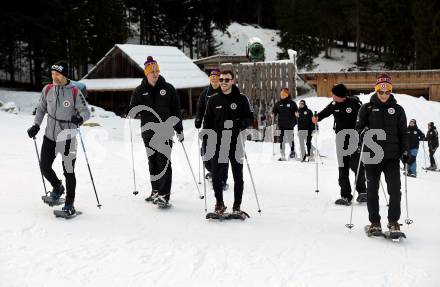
top-left (356, 74), bottom-right (408, 234)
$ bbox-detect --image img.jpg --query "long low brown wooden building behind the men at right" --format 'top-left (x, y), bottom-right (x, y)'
top-left (298, 70), bottom-right (440, 101)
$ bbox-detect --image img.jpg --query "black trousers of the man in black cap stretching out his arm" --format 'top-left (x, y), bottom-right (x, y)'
top-left (338, 153), bottom-right (367, 201)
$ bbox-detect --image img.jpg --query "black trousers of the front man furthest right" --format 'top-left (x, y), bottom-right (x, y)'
top-left (365, 159), bottom-right (402, 223)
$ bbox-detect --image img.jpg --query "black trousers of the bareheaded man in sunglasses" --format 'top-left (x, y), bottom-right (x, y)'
top-left (212, 142), bottom-right (244, 207)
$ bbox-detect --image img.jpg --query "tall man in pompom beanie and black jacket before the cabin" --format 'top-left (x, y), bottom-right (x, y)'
top-left (129, 56), bottom-right (184, 206)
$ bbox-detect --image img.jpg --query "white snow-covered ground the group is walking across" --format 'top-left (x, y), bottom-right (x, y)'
top-left (0, 92), bottom-right (440, 287)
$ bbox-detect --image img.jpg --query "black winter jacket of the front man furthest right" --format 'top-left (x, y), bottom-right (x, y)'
top-left (356, 94), bottom-right (408, 159)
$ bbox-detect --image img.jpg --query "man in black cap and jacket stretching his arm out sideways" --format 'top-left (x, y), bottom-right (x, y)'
top-left (312, 84), bottom-right (367, 205)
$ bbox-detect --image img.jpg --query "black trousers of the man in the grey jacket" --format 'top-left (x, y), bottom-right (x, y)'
top-left (40, 136), bottom-right (76, 205)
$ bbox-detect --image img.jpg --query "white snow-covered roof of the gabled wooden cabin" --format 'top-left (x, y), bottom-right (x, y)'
top-left (81, 44), bottom-right (209, 90)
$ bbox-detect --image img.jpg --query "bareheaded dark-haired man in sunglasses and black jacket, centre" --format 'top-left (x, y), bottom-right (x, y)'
top-left (203, 70), bottom-right (253, 214)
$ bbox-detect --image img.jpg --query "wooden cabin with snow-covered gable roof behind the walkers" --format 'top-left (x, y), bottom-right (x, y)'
top-left (80, 44), bottom-right (209, 117)
